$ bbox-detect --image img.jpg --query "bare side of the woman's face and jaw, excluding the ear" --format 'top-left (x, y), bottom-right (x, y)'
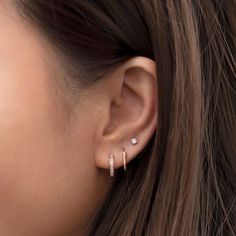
top-left (0, 3), bottom-right (108, 236)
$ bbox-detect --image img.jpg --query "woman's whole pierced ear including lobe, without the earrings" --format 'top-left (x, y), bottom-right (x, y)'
top-left (95, 56), bottom-right (157, 173)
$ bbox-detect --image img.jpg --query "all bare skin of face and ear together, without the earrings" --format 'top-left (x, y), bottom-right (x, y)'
top-left (0, 2), bottom-right (157, 236)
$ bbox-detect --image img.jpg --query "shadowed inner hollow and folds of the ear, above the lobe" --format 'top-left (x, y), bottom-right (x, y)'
top-left (104, 64), bottom-right (157, 136)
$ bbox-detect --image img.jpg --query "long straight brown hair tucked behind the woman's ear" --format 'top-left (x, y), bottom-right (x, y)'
top-left (13, 0), bottom-right (236, 236)
